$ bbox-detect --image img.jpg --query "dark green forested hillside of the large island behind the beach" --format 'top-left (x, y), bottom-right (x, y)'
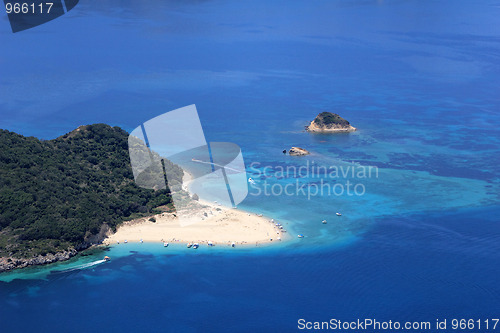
top-left (0, 124), bottom-right (183, 262)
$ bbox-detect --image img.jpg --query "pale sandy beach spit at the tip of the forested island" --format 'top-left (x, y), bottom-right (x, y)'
top-left (103, 203), bottom-right (284, 246)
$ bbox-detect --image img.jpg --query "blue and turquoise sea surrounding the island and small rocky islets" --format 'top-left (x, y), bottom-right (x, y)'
top-left (0, 0), bottom-right (500, 333)
